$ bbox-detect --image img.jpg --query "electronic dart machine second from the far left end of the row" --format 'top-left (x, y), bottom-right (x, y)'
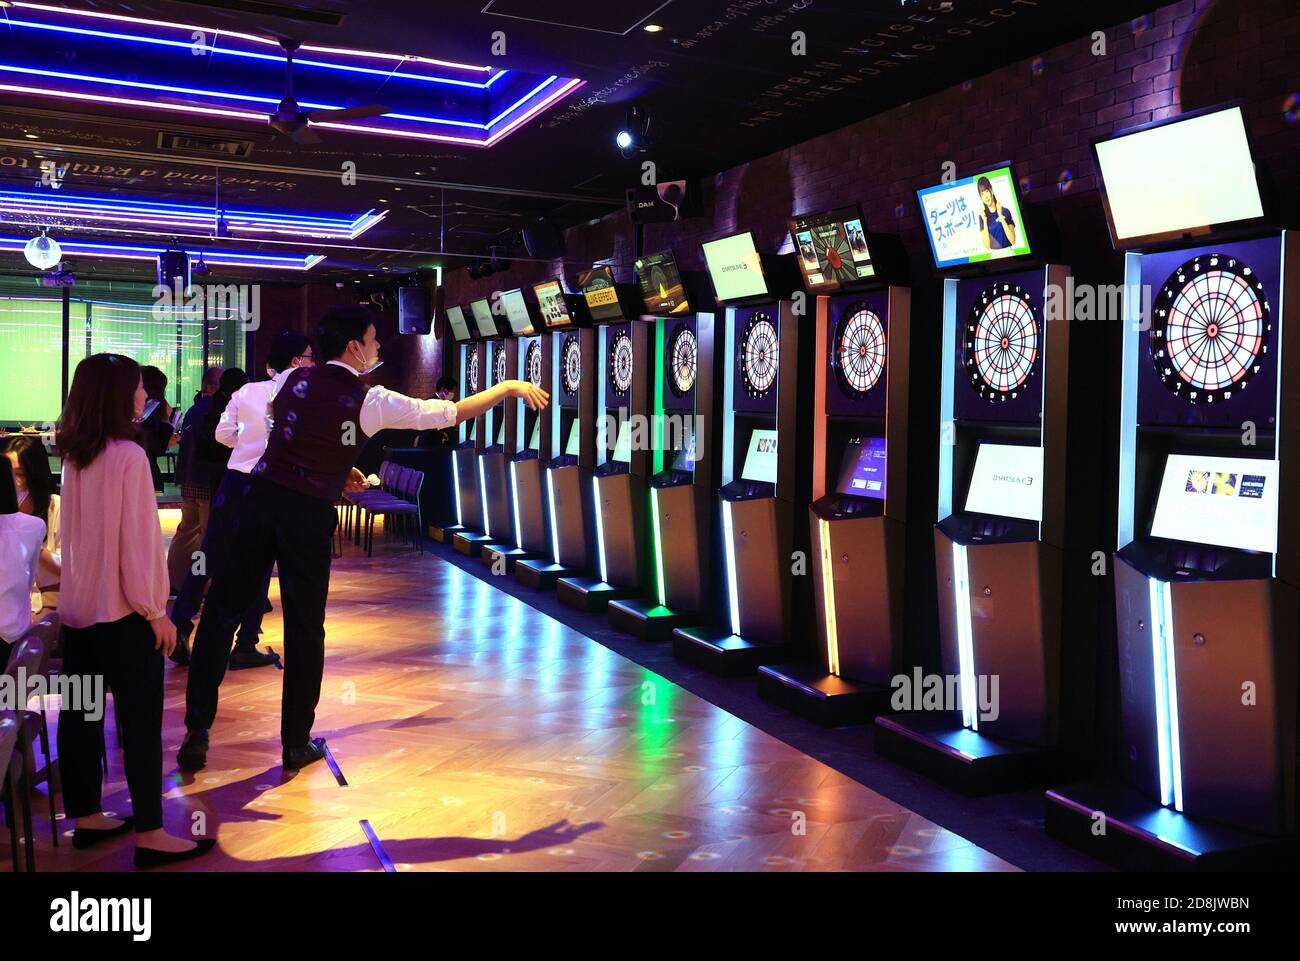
top-left (451, 298), bottom-right (510, 555)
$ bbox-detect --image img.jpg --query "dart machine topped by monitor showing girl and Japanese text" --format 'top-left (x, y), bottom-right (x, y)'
top-left (875, 165), bottom-right (1073, 793)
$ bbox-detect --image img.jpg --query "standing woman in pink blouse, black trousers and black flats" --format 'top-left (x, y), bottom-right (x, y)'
top-left (59, 354), bottom-right (216, 867)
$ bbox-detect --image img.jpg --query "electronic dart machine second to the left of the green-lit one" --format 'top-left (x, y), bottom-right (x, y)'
top-left (515, 280), bottom-right (595, 590)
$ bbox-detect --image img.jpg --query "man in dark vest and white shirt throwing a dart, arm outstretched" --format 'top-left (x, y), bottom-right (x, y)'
top-left (177, 307), bottom-right (550, 771)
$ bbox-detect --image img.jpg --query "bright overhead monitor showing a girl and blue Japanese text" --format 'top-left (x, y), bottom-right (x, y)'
top-left (917, 166), bottom-right (1031, 268)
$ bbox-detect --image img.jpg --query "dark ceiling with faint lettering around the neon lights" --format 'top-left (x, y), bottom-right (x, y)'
top-left (0, 0), bottom-right (1151, 280)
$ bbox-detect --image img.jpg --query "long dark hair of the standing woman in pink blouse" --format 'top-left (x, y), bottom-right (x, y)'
top-left (57, 354), bottom-right (140, 469)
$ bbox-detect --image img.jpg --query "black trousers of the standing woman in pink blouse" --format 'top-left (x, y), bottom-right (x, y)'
top-left (59, 614), bottom-right (163, 831)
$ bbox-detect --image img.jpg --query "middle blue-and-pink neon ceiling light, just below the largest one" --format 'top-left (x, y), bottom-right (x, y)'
top-left (0, 190), bottom-right (387, 241)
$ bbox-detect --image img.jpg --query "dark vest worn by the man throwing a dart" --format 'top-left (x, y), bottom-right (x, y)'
top-left (252, 364), bottom-right (367, 503)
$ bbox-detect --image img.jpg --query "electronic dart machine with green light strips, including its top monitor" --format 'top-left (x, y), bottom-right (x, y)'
top-left (608, 250), bottom-right (723, 640)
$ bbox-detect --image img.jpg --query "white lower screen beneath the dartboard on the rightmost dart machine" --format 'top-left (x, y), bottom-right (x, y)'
top-left (1151, 454), bottom-right (1278, 554)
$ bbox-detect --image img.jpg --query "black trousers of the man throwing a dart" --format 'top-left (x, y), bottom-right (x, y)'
top-left (185, 477), bottom-right (338, 748)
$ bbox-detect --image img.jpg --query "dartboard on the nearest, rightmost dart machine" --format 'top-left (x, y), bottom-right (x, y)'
top-left (1151, 254), bottom-right (1271, 403)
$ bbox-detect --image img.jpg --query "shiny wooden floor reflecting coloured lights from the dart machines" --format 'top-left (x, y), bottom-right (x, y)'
top-left (10, 511), bottom-right (1015, 871)
